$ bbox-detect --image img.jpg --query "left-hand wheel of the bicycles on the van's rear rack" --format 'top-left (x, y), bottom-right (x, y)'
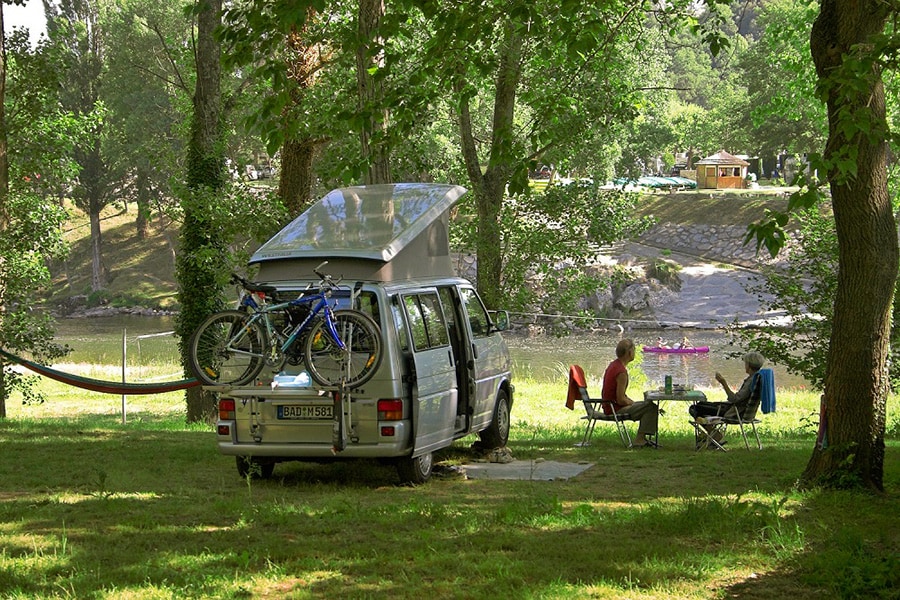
top-left (190, 310), bottom-right (266, 385)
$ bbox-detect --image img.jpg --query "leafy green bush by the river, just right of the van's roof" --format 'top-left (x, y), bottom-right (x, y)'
top-left (451, 182), bottom-right (653, 314)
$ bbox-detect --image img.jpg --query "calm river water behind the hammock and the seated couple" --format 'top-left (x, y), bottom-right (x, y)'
top-left (57, 315), bottom-right (808, 388)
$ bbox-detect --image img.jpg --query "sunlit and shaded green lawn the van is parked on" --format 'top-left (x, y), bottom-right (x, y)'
top-left (0, 370), bottom-right (900, 599)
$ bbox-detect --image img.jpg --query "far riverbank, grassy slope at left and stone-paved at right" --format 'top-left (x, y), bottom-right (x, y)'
top-left (46, 188), bottom-right (786, 328)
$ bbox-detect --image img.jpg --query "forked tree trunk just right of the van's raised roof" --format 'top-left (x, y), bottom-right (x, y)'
top-left (457, 25), bottom-right (522, 308)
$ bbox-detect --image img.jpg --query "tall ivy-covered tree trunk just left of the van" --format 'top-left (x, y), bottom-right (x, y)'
top-left (176, 0), bottom-right (226, 423)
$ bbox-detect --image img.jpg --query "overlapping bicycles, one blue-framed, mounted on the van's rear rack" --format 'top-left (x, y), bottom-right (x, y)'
top-left (189, 261), bottom-right (382, 388)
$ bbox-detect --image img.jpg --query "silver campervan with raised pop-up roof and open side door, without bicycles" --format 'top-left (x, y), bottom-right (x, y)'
top-left (215, 183), bottom-right (513, 483)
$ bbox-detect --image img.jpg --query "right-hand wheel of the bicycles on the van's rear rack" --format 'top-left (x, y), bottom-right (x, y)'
top-left (304, 310), bottom-right (382, 387)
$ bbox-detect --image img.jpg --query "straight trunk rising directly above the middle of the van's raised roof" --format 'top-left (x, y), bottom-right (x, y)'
top-left (356, 0), bottom-right (391, 184)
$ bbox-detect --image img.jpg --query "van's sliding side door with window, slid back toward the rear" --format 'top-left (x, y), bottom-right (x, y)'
top-left (401, 290), bottom-right (458, 457)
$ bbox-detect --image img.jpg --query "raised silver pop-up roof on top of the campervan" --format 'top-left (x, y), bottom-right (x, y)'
top-left (250, 183), bottom-right (466, 281)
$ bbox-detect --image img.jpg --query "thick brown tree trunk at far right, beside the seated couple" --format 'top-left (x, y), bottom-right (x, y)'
top-left (802, 0), bottom-right (898, 490)
